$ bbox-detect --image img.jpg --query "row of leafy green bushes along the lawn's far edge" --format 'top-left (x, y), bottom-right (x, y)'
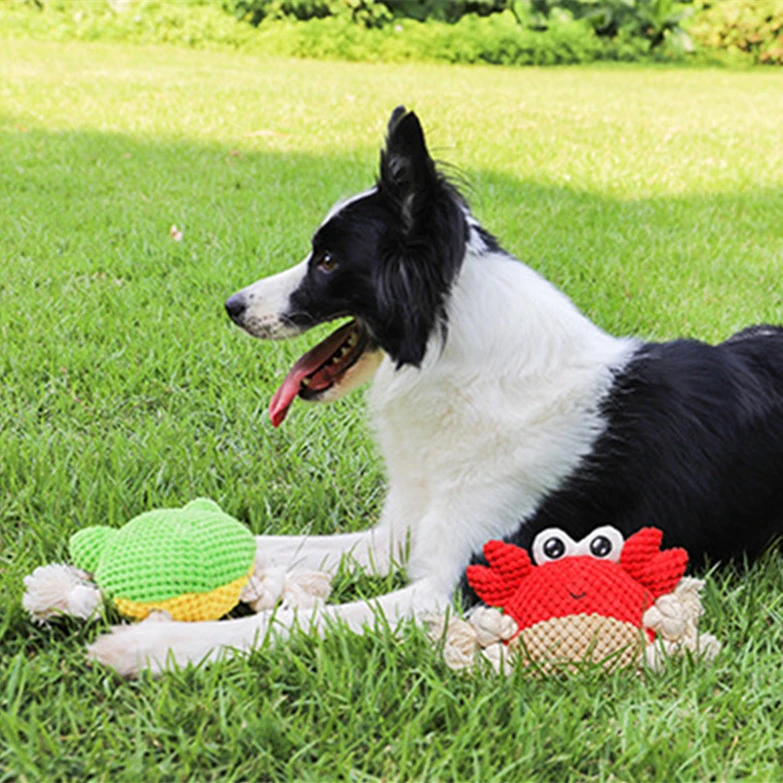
top-left (0, 0), bottom-right (783, 65)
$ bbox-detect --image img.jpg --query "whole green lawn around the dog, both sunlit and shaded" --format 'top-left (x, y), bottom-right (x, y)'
top-left (0, 41), bottom-right (783, 781)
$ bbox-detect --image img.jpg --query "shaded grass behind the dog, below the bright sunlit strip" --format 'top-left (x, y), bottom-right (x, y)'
top-left (0, 121), bottom-right (783, 648)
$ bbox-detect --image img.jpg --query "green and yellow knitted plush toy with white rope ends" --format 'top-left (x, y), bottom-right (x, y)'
top-left (22, 498), bottom-right (331, 623)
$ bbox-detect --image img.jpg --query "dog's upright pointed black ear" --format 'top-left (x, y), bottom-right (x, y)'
top-left (378, 106), bottom-right (439, 232)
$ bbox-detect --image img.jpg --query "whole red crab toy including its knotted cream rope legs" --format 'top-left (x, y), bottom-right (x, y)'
top-left (430, 526), bottom-right (720, 673)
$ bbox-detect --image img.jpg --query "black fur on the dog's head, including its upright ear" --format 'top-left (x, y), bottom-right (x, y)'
top-left (285, 107), bottom-right (468, 367)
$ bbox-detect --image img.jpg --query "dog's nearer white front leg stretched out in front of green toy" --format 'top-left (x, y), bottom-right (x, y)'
top-left (88, 579), bottom-right (449, 677)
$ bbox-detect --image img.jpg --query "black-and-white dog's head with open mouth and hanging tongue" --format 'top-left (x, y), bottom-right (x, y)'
top-left (226, 106), bottom-right (468, 426)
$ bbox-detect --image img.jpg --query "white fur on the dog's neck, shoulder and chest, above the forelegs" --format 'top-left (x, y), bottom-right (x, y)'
top-left (370, 242), bottom-right (635, 592)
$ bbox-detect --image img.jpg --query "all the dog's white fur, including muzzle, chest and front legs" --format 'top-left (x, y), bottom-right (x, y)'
top-left (90, 228), bottom-right (636, 675)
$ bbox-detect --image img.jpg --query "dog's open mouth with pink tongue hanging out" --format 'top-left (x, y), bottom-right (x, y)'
top-left (269, 320), bottom-right (372, 427)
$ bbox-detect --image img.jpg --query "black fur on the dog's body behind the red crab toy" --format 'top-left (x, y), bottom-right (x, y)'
top-left (463, 326), bottom-right (783, 594)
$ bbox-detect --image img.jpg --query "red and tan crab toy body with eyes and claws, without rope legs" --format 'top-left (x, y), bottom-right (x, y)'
top-left (460, 526), bottom-right (700, 669)
